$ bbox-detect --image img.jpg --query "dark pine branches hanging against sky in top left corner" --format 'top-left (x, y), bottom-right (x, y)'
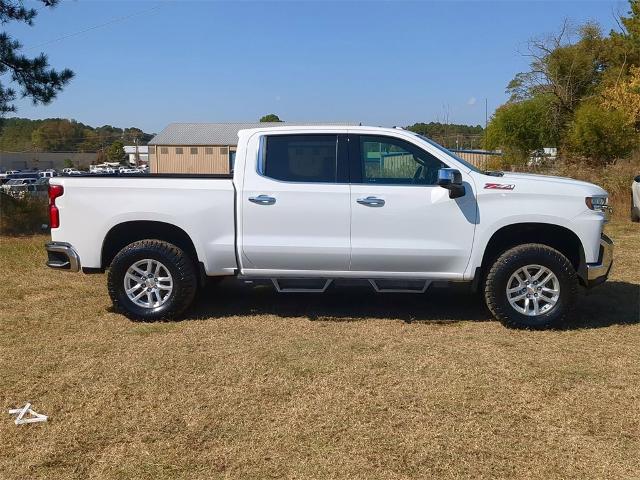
top-left (0, 0), bottom-right (73, 114)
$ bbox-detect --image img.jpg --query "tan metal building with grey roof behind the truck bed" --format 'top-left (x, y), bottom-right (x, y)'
top-left (148, 122), bottom-right (357, 173)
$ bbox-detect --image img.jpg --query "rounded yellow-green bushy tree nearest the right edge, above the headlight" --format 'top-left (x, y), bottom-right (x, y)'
top-left (567, 102), bottom-right (638, 163)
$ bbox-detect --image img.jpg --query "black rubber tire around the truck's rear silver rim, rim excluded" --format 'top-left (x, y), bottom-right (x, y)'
top-left (107, 240), bottom-right (198, 321)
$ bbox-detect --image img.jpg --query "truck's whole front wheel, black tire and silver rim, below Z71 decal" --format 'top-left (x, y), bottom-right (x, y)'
top-left (484, 244), bottom-right (578, 329)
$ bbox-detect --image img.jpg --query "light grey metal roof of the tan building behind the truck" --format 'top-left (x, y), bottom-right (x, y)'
top-left (149, 122), bottom-right (358, 145)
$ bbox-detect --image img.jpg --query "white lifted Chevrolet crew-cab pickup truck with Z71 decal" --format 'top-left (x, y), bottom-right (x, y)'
top-left (46, 126), bottom-right (613, 328)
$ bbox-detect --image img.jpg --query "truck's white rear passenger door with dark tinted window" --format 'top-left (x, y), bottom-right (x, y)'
top-left (240, 133), bottom-right (351, 276)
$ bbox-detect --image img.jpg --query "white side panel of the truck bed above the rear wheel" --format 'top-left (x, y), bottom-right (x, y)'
top-left (50, 174), bottom-right (237, 275)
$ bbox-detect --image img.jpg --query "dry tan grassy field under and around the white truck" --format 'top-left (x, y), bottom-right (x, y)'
top-left (0, 222), bottom-right (640, 480)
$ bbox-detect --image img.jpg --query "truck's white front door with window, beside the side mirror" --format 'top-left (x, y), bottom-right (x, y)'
top-left (349, 135), bottom-right (476, 279)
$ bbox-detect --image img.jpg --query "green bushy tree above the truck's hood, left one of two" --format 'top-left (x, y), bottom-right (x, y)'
top-left (485, 95), bottom-right (559, 163)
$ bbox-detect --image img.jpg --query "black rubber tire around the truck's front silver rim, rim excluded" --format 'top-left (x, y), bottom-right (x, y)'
top-left (484, 243), bottom-right (578, 330)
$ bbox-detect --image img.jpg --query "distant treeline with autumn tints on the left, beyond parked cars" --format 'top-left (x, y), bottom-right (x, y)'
top-left (0, 118), bottom-right (153, 152)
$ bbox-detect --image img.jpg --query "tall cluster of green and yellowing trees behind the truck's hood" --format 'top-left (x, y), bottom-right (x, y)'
top-left (485, 0), bottom-right (640, 165)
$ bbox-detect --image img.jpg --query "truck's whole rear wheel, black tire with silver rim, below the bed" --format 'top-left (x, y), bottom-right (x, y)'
top-left (108, 240), bottom-right (198, 321)
